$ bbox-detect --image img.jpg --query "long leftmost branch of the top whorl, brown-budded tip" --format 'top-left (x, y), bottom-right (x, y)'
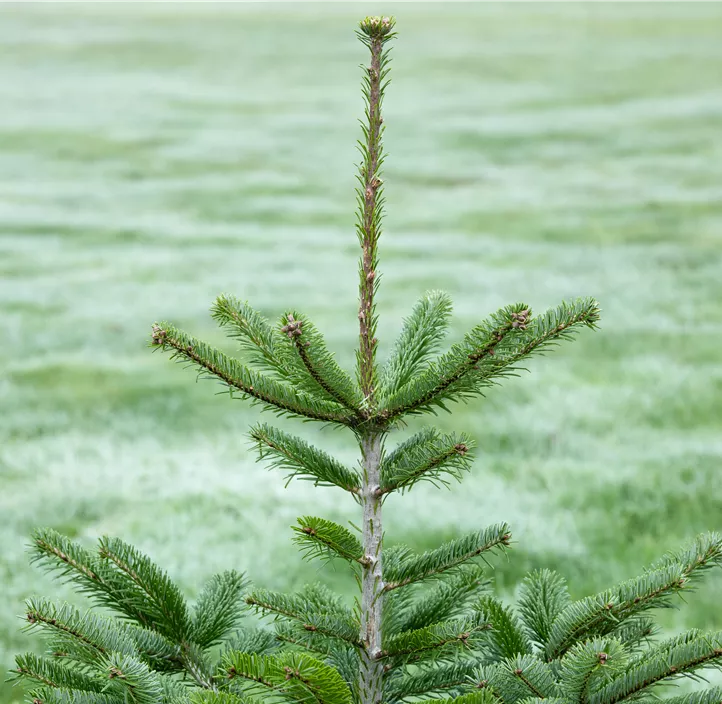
top-left (152, 323), bottom-right (355, 425)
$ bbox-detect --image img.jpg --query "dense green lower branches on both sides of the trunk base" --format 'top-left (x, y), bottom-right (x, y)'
top-left (14, 525), bottom-right (722, 704)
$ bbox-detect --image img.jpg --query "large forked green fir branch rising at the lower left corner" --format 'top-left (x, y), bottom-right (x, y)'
top-left (28, 530), bottom-right (248, 686)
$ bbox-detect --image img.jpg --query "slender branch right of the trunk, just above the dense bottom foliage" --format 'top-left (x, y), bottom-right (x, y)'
top-left (384, 523), bottom-right (511, 591)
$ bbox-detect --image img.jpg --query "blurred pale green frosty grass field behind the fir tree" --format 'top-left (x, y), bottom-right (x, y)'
top-left (0, 1), bottom-right (722, 702)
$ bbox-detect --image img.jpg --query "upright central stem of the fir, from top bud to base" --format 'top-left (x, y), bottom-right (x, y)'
top-left (356, 17), bottom-right (394, 704)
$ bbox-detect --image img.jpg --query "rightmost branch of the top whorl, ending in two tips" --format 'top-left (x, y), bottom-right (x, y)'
top-left (379, 298), bottom-right (599, 421)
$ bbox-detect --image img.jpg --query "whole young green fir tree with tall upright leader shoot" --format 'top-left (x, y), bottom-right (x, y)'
top-left (9, 17), bottom-right (722, 704)
